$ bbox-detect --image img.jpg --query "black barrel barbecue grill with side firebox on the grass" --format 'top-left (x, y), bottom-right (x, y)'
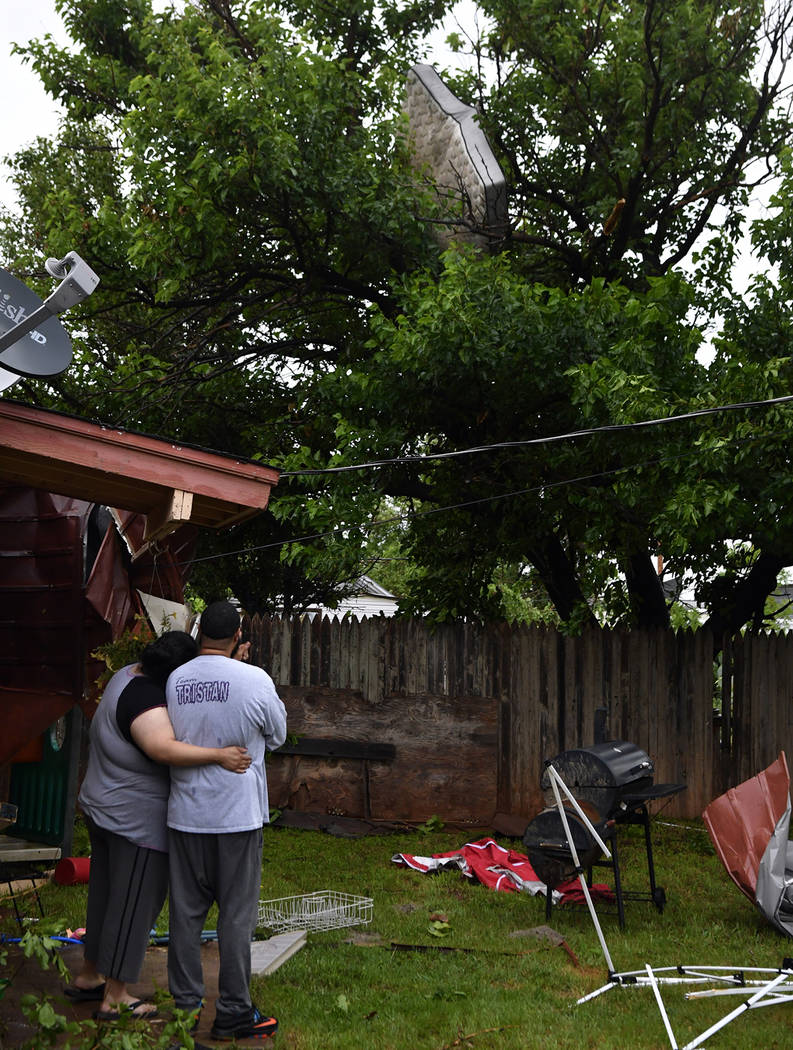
top-left (523, 740), bottom-right (686, 927)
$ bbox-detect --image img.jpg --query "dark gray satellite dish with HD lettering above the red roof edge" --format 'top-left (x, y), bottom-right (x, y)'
top-left (0, 252), bottom-right (99, 389)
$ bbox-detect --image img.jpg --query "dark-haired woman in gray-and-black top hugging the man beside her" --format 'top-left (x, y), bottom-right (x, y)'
top-left (66, 631), bottom-right (250, 1021)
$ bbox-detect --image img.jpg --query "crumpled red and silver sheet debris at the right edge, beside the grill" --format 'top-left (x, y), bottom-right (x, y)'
top-left (703, 751), bottom-right (793, 937)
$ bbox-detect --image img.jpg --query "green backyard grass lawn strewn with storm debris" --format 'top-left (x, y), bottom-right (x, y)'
top-left (5, 821), bottom-right (793, 1050)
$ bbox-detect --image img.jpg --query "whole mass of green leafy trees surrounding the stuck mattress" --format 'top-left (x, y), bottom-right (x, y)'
top-left (2, 0), bottom-right (793, 630)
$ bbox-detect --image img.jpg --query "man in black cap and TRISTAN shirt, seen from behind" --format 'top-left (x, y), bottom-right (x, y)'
top-left (166, 602), bottom-right (287, 1042)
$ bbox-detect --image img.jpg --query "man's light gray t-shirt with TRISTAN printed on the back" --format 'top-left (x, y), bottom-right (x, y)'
top-left (166, 655), bottom-right (287, 834)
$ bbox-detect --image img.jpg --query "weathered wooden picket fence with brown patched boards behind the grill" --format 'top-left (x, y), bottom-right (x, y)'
top-left (249, 617), bottom-right (793, 824)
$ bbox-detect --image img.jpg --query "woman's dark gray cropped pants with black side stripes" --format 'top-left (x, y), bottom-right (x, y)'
top-left (85, 816), bottom-right (168, 984)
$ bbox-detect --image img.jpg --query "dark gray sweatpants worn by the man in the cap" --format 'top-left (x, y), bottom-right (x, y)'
top-left (168, 828), bottom-right (263, 1024)
